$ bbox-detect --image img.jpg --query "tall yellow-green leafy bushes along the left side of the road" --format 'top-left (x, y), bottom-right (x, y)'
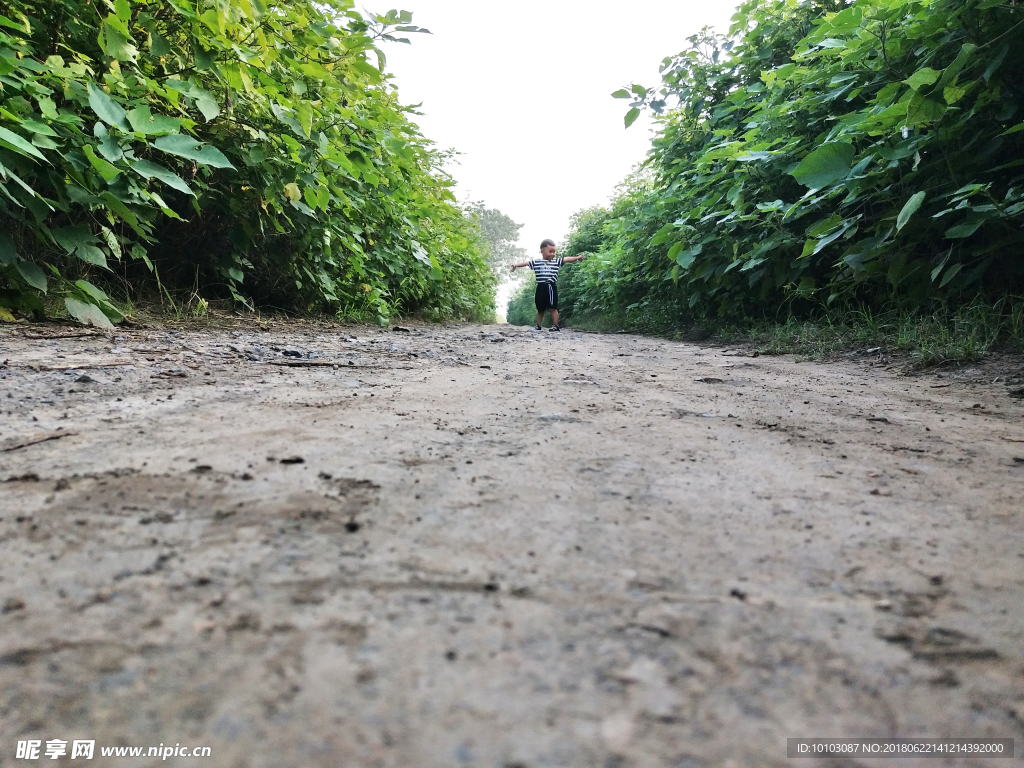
top-left (0, 0), bottom-right (495, 326)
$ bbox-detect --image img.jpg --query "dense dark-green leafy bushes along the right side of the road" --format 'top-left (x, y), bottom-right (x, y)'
top-left (508, 0), bottom-right (1024, 361)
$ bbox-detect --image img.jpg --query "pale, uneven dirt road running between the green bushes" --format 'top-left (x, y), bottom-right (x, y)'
top-left (0, 325), bottom-right (1024, 768)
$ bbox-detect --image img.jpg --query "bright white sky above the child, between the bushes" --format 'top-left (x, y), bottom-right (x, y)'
top-left (380, 0), bottom-right (737, 313)
